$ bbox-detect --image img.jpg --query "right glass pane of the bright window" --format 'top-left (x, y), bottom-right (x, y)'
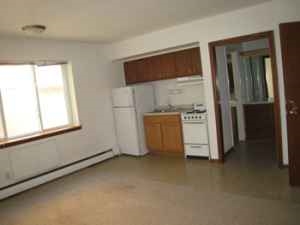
top-left (36, 65), bottom-right (69, 129)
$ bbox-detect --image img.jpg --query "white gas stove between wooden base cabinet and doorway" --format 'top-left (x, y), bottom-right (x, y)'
top-left (181, 110), bottom-right (209, 157)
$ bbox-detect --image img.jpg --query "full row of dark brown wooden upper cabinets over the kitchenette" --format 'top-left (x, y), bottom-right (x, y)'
top-left (124, 47), bottom-right (202, 84)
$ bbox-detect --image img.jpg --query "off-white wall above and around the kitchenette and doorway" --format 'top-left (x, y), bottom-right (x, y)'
top-left (110, 0), bottom-right (300, 164)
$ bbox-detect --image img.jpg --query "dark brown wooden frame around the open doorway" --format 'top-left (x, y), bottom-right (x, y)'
top-left (208, 31), bottom-right (283, 167)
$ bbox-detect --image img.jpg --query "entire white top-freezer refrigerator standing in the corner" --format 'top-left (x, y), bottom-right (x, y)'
top-left (112, 85), bottom-right (154, 156)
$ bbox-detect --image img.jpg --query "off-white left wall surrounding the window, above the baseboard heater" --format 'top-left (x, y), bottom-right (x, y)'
top-left (0, 39), bottom-right (123, 186)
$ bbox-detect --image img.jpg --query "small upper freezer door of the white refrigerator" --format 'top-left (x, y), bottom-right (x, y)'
top-left (112, 87), bottom-right (134, 107)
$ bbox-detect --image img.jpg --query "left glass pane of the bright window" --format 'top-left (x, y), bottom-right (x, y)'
top-left (0, 65), bottom-right (40, 137)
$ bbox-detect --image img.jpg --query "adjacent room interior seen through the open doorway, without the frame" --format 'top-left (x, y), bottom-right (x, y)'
top-left (214, 37), bottom-right (282, 167)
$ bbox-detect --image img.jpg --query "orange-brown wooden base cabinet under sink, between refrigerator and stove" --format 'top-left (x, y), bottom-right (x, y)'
top-left (144, 115), bottom-right (184, 154)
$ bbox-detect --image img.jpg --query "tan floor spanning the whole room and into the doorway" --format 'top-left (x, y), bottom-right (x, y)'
top-left (0, 143), bottom-right (300, 225)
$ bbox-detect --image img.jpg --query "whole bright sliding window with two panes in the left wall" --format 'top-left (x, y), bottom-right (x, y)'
top-left (0, 64), bottom-right (76, 140)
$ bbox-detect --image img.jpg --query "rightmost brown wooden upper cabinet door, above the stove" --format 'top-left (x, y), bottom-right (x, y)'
top-left (175, 48), bottom-right (202, 77)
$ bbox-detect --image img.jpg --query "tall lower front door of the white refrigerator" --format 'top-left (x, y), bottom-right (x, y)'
top-left (114, 108), bottom-right (140, 156)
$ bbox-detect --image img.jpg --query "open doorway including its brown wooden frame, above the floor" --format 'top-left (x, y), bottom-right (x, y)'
top-left (209, 31), bottom-right (282, 166)
